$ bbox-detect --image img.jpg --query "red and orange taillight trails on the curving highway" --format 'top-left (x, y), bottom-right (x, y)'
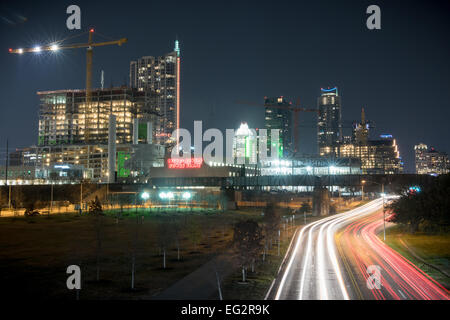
top-left (337, 211), bottom-right (449, 300)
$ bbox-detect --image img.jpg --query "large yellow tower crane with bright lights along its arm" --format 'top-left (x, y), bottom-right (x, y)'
top-left (9, 28), bottom-right (128, 142)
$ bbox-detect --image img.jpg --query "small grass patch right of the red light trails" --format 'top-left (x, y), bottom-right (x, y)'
top-left (381, 226), bottom-right (450, 289)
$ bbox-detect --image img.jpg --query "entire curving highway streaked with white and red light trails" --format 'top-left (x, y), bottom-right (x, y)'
top-left (272, 199), bottom-right (449, 300)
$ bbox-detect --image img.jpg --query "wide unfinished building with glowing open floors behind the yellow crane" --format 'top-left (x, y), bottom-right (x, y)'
top-left (37, 87), bottom-right (158, 146)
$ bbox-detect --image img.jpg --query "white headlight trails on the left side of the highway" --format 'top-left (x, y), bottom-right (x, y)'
top-left (275, 199), bottom-right (382, 300)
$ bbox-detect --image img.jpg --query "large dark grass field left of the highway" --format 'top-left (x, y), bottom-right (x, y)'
top-left (0, 209), bottom-right (261, 299)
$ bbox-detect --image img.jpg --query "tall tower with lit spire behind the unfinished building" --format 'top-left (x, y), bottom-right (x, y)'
top-left (130, 40), bottom-right (181, 143)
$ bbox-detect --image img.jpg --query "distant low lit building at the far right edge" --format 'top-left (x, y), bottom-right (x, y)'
top-left (414, 143), bottom-right (450, 175)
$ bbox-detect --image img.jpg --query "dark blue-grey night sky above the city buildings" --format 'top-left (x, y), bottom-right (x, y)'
top-left (0, 0), bottom-right (450, 172)
